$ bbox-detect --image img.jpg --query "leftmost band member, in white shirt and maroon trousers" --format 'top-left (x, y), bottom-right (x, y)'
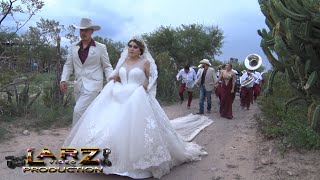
top-left (176, 65), bottom-right (197, 109)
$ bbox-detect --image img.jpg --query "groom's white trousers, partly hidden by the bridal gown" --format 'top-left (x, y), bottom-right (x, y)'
top-left (72, 86), bottom-right (99, 127)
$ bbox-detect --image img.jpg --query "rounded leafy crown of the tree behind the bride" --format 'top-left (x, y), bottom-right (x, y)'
top-left (144, 24), bottom-right (223, 65)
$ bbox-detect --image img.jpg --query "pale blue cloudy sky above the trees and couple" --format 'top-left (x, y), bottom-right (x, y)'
top-left (6, 0), bottom-right (271, 69)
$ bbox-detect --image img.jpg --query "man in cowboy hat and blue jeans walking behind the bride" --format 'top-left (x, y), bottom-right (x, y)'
top-left (196, 59), bottom-right (217, 114)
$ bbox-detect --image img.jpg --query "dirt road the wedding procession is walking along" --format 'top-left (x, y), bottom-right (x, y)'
top-left (0, 97), bottom-right (320, 180)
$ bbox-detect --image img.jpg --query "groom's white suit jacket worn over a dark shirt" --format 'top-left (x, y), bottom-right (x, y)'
top-left (61, 41), bottom-right (113, 92)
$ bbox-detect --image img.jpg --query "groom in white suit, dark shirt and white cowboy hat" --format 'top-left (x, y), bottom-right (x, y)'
top-left (60, 18), bottom-right (113, 126)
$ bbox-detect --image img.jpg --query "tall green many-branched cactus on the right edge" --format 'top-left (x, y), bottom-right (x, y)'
top-left (258, 0), bottom-right (320, 132)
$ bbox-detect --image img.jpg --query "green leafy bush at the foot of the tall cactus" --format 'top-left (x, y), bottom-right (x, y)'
top-left (259, 71), bottom-right (320, 149)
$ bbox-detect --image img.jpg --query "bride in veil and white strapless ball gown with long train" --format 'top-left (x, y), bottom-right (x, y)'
top-left (63, 37), bottom-right (212, 178)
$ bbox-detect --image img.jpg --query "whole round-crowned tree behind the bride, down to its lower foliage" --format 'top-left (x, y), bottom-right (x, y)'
top-left (143, 24), bottom-right (223, 101)
